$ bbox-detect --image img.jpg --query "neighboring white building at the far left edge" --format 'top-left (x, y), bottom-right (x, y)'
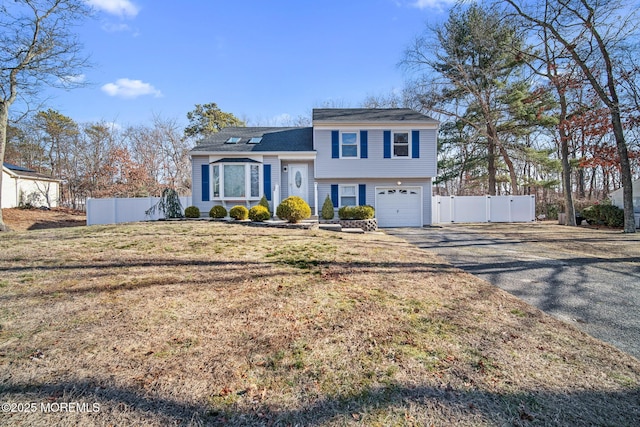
top-left (1, 163), bottom-right (60, 209)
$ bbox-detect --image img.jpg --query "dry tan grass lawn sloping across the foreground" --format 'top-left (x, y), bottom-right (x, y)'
top-left (0, 222), bottom-right (640, 426)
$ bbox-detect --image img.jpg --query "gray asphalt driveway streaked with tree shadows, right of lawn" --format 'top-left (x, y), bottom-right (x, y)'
top-left (386, 224), bottom-right (640, 359)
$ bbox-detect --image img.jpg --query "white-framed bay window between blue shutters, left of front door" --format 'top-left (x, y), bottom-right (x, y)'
top-left (212, 163), bottom-right (261, 199)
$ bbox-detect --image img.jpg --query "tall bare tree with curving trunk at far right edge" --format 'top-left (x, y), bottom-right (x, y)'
top-left (499, 0), bottom-right (638, 233)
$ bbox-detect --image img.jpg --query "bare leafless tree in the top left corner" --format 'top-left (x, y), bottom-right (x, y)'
top-left (0, 0), bottom-right (90, 231)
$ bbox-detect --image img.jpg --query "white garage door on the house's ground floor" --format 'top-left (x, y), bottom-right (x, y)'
top-left (376, 187), bottom-right (422, 227)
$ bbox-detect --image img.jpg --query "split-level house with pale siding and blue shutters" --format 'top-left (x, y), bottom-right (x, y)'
top-left (190, 108), bottom-right (438, 227)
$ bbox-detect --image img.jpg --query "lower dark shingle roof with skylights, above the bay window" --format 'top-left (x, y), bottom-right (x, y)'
top-left (191, 127), bottom-right (313, 153)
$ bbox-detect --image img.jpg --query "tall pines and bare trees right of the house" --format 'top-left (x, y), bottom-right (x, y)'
top-left (364, 0), bottom-right (640, 231)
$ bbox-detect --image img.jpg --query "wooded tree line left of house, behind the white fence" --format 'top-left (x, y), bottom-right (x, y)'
top-left (5, 109), bottom-right (192, 208)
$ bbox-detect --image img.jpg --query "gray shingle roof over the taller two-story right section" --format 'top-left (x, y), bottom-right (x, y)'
top-left (313, 108), bottom-right (438, 123)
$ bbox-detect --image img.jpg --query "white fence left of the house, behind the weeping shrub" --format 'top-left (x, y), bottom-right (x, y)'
top-left (87, 197), bottom-right (191, 225)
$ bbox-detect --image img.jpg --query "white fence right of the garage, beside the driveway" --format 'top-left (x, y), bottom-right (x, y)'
top-left (431, 196), bottom-right (536, 224)
